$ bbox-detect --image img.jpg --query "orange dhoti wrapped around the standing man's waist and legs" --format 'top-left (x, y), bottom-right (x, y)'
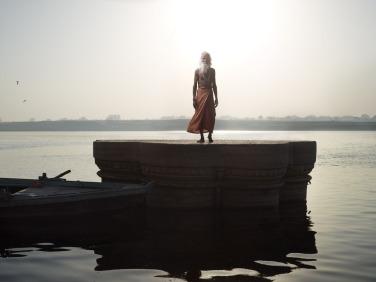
top-left (187, 88), bottom-right (215, 133)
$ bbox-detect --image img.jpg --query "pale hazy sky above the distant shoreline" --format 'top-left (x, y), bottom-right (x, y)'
top-left (0, 0), bottom-right (376, 121)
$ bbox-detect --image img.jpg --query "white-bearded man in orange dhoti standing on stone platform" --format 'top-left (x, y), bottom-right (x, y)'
top-left (187, 52), bottom-right (218, 143)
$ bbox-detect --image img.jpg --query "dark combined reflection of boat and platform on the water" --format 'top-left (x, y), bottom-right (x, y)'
top-left (1, 205), bottom-right (317, 281)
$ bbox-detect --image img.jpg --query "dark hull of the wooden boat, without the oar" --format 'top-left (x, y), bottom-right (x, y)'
top-left (0, 182), bottom-right (148, 220)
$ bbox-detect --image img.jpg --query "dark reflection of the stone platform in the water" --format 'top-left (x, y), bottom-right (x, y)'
top-left (95, 205), bottom-right (317, 277)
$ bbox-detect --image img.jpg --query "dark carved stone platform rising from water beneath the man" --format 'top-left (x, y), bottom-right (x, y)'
top-left (94, 140), bottom-right (316, 208)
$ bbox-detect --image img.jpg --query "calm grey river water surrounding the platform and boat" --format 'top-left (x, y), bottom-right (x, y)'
top-left (0, 131), bottom-right (376, 281)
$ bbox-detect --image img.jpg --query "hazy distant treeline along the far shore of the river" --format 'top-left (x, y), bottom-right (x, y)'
top-left (0, 119), bottom-right (376, 131)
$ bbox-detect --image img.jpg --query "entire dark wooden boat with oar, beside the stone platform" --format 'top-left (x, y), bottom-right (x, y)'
top-left (0, 171), bottom-right (151, 219)
